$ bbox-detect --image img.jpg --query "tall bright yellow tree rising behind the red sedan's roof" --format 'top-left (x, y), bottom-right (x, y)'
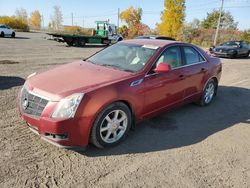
top-left (156, 0), bottom-right (185, 38)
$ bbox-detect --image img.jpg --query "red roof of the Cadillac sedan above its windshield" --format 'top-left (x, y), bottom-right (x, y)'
top-left (121, 39), bottom-right (180, 47)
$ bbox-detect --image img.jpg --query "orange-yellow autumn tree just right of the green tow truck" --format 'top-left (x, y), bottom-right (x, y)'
top-left (120, 6), bottom-right (142, 37)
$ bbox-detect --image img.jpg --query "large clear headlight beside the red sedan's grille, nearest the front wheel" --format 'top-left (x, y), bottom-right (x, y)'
top-left (52, 93), bottom-right (84, 118)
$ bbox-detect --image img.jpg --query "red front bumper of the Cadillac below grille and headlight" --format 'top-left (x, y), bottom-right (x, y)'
top-left (21, 112), bottom-right (91, 148)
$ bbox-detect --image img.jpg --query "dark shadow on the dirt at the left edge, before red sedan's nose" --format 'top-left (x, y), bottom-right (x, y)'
top-left (0, 76), bottom-right (25, 90)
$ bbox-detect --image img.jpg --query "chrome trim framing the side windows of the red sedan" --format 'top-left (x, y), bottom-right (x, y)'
top-left (144, 44), bottom-right (208, 78)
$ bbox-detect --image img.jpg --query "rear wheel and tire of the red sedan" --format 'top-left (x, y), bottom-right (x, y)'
top-left (199, 79), bottom-right (218, 106)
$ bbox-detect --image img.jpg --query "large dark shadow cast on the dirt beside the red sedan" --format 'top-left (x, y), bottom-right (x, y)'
top-left (78, 86), bottom-right (250, 157)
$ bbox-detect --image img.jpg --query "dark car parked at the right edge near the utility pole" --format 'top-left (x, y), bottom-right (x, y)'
top-left (212, 41), bottom-right (250, 58)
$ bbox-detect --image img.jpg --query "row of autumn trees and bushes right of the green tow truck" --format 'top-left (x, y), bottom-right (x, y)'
top-left (119, 0), bottom-right (250, 46)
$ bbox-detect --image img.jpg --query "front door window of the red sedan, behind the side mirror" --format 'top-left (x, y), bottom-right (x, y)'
top-left (156, 46), bottom-right (182, 68)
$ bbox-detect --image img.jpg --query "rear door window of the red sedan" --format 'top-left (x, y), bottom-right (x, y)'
top-left (183, 46), bottom-right (205, 65)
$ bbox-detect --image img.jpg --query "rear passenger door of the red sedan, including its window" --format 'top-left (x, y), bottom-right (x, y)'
top-left (182, 46), bottom-right (209, 100)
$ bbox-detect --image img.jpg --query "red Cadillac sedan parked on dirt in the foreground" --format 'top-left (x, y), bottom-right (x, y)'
top-left (18, 39), bottom-right (222, 148)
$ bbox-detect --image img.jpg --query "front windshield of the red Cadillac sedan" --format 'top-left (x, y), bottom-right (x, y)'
top-left (86, 43), bottom-right (158, 72)
